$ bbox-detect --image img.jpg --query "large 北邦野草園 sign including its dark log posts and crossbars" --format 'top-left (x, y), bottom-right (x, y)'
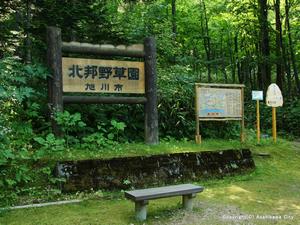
top-left (47, 27), bottom-right (159, 144)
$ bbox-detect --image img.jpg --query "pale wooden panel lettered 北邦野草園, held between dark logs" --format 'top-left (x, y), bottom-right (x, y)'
top-left (62, 58), bottom-right (145, 94)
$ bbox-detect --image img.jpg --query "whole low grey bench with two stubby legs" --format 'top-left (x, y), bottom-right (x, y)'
top-left (125, 184), bottom-right (203, 221)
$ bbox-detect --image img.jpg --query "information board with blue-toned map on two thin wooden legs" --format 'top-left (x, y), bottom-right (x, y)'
top-left (195, 83), bottom-right (244, 143)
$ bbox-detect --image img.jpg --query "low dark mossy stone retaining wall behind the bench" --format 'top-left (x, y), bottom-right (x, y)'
top-left (56, 149), bottom-right (255, 192)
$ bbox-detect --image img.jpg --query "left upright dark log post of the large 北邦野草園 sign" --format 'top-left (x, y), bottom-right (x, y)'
top-left (47, 27), bottom-right (63, 136)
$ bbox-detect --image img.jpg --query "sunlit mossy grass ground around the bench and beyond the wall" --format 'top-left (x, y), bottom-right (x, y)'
top-left (0, 140), bottom-right (300, 225)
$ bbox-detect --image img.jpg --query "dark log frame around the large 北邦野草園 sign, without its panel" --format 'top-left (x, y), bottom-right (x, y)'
top-left (47, 27), bottom-right (159, 145)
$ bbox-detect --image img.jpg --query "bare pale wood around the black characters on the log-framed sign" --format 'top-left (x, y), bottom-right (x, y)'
top-left (62, 57), bottom-right (145, 94)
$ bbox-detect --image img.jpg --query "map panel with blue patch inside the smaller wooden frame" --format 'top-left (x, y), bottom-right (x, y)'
top-left (197, 87), bottom-right (243, 118)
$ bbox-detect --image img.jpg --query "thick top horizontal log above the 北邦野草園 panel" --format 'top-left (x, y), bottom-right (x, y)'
top-left (62, 42), bottom-right (145, 58)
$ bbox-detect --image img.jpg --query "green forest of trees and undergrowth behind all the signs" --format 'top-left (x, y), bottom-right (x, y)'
top-left (0, 0), bottom-right (300, 207)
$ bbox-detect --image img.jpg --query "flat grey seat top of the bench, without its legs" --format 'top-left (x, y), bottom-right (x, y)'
top-left (125, 184), bottom-right (203, 201)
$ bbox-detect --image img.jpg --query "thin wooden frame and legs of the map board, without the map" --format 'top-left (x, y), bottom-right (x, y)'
top-left (195, 83), bottom-right (245, 144)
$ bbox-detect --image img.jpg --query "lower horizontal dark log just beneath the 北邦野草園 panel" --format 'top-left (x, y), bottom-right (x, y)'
top-left (63, 96), bottom-right (147, 104)
